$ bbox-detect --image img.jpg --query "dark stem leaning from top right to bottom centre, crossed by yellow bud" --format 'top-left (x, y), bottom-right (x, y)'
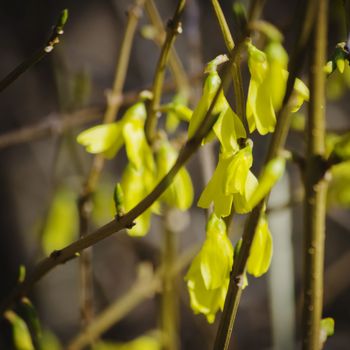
top-left (214, 0), bottom-right (317, 350)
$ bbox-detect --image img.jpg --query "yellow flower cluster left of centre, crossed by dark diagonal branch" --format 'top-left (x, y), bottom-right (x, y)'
top-left (77, 102), bottom-right (193, 236)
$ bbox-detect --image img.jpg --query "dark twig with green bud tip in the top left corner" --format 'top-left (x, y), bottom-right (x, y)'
top-left (0, 9), bottom-right (68, 92)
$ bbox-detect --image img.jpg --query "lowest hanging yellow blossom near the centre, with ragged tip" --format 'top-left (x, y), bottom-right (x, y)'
top-left (185, 214), bottom-right (233, 323)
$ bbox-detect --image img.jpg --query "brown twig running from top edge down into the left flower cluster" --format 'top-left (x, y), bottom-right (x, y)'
top-left (145, 0), bottom-right (186, 145)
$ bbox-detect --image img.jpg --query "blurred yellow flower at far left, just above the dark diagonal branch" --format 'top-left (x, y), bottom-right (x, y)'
top-left (41, 186), bottom-right (78, 254)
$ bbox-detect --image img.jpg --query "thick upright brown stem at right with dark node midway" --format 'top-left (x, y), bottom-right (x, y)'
top-left (302, 0), bottom-right (328, 350)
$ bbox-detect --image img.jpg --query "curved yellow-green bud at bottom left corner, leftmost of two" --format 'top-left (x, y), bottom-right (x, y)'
top-left (4, 310), bottom-right (35, 350)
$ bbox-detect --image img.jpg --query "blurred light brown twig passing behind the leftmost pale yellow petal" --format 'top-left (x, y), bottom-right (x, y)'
top-left (78, 0), bottom-right (145, 325)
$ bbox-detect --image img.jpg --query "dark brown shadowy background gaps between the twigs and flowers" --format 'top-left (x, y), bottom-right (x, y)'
top-left (0, 0), bottom-right (350, 349)
